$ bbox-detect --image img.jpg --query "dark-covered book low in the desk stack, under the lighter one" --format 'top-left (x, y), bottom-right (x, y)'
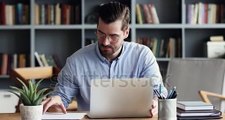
top-left (177, 109), bottom-right (221, 117)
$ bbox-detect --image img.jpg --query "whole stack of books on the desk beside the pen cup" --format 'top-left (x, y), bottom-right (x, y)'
top-left (177, 101), bottom-right (221, 120)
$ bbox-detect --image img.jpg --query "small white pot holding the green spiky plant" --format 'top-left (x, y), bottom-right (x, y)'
top-left (20, 104), bottom-right (43, 120)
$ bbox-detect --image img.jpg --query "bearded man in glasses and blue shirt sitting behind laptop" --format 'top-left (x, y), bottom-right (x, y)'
top-left (43, 2), bottom-right (167, 115)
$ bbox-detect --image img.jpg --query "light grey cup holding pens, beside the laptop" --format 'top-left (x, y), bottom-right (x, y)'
top-left (158, 98), bottom-right (177, 120)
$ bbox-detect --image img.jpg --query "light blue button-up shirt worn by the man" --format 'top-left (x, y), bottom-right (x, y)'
top-left (52, 42), bottom-right (167, 111)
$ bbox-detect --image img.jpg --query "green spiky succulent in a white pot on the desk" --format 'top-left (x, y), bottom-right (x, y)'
top-left (10, 78), bottom-right (49, 120)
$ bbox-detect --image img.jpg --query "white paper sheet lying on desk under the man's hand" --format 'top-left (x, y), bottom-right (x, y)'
top-left (42, 112), bottom-right (87, 120)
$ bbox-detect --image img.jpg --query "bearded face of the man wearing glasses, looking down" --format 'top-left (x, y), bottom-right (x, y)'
top-left (96, 19), bottom-right (129, 59)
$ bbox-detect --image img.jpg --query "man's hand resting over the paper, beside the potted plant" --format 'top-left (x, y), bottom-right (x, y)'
top-left (42, 96), bottom-right (66, 113)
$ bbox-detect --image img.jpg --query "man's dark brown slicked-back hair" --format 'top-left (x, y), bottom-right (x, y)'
top-left (99, 1), bottom-right (130, 30)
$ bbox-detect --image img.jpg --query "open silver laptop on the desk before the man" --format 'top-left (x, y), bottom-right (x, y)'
top-left (87, 78), bottom-right (153, 118)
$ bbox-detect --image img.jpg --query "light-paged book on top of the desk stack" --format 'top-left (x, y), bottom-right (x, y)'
top-left (177, 101), bottom-right (214, 110)
